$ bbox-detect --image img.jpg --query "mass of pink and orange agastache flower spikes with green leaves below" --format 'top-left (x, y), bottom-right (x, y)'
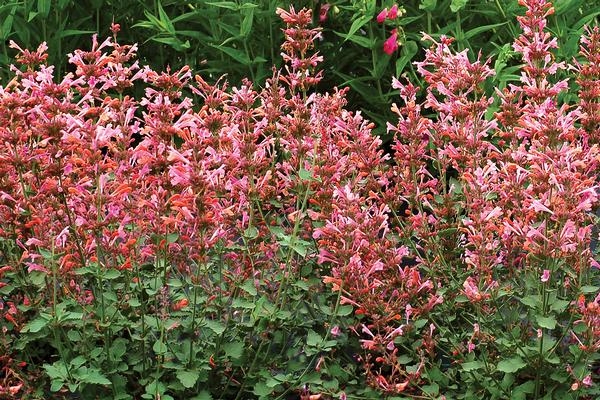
top-left (0, 0), bottom-right (600, 399)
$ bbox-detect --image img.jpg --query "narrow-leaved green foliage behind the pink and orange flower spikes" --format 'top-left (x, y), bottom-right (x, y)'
top-left (0, 0), bottom-right (600, 135)
